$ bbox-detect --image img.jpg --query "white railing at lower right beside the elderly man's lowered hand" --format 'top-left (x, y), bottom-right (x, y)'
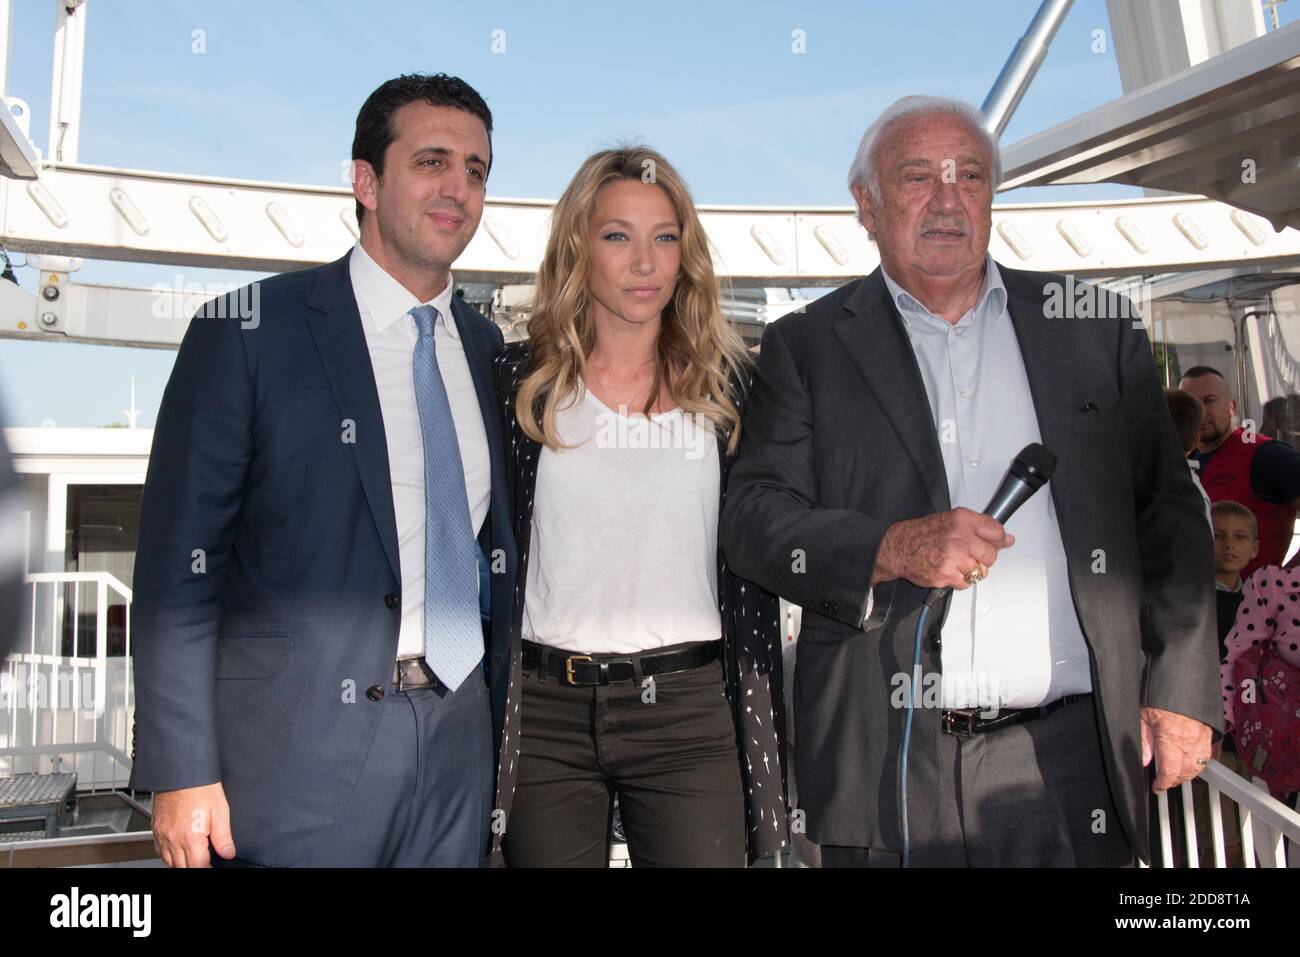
top-left (1156, 761), bottom-right (1300, 867)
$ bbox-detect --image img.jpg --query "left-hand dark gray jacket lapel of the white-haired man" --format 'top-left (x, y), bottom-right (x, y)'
top-left (835, 269), bottom-right (952, 511)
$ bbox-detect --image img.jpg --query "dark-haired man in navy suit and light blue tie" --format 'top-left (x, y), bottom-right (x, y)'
top-left (133, 74), bottom-right (515, 867)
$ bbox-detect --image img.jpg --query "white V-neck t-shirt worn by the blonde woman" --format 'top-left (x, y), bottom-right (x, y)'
top-left (523, 389), bottom-right (722, 654)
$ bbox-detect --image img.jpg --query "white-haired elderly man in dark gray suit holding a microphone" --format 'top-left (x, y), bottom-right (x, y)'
top-left (722, 96), bottom-right (1222, 866)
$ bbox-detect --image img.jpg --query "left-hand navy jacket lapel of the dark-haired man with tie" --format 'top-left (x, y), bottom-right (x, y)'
top-left (307, 254), bottom-right (402, 581)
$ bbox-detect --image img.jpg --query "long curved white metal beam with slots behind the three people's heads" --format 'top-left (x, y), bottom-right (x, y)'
top-left (0, 165), bottom-right (1300, 295)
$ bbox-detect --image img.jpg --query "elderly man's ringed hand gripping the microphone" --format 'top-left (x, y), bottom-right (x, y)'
top-left (871, 508), bottom-right (1015, 589)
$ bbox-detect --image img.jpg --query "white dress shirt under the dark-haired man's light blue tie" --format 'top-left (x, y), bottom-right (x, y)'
top-left (348, 243), bottom-right (491, 657)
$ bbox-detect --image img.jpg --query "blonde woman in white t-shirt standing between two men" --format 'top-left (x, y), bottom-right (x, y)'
top-left (493, 147), bottom-right (788, 867)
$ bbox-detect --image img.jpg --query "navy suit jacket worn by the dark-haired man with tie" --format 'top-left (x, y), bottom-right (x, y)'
top-left (131, 255), bottom-right (515, 865)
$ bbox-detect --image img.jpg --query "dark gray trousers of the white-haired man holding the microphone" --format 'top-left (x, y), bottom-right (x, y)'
top-left (822, 696), bottom-right (1134, 867)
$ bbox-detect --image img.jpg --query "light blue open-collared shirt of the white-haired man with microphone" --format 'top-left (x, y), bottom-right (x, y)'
top-left (881, 256), bottom-right (1092, 709)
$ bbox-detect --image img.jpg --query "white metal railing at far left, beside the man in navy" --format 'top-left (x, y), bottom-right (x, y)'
top-left (0, 572), bottom-right (135, 791)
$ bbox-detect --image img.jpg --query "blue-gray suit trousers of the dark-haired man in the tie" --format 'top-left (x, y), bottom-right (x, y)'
top-left (286, 668), bottom-right (493, 867)
